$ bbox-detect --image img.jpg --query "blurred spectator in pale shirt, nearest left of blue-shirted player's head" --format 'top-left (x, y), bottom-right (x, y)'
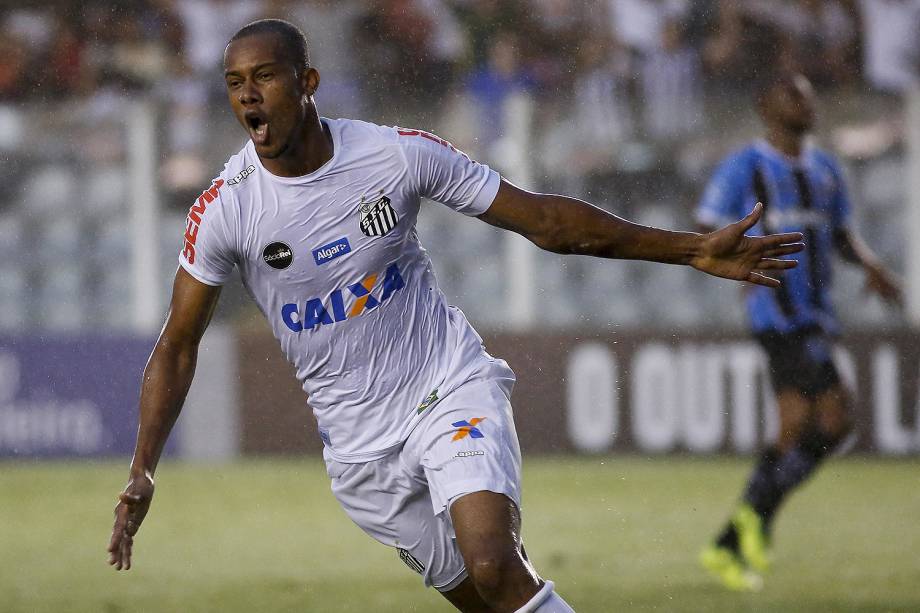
top-left (640, 19), bottom-right (704, 139)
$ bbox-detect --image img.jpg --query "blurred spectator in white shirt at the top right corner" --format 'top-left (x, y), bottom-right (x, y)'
top-left (860, 0), bottom-right (920, 93)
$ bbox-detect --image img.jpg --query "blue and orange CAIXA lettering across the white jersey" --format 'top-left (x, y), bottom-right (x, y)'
top-left (281, 262), bottom-right (406, 332)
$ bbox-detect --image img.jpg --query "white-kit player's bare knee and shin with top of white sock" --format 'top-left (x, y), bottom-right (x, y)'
top-left (450, 491), bottom-right (572, 613)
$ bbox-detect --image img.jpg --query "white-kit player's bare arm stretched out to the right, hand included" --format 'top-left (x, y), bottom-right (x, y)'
top-left (479, 180), bottom-right (804, 287)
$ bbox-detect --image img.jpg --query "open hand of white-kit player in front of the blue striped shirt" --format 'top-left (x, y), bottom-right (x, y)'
top-left (690, 202), bottom-right (805, 287)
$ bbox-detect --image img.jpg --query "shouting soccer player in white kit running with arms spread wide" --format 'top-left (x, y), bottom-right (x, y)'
top-left (109, 20), bottom-right (801, 613)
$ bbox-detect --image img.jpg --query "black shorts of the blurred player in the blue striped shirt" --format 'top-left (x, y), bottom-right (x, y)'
top-left (755, 330), bottom-right (840, 398)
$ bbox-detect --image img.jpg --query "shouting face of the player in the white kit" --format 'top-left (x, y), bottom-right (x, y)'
top-left (224, 34), bottom-right (316, 159)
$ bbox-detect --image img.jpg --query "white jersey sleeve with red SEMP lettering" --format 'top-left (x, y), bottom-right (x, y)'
top-left (179, 179), bottom-right (236, 285)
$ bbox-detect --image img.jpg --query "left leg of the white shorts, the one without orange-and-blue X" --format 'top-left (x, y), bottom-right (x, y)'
top-left (327, 453), bottom-right (466, 591)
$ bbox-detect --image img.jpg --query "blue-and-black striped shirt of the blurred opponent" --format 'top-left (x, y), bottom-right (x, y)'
top-left (697, 141), bottom-right (850, 332)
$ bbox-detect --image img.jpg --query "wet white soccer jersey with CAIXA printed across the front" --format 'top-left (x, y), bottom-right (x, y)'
top-left (179, 119), bottom-right (499, 462)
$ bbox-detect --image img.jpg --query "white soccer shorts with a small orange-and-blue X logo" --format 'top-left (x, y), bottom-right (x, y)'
top-left (325, 360), bottom-right (521, 592)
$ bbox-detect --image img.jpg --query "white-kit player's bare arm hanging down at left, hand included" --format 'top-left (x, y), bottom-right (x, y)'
top-left (108, 267), bottom-right (220, 570)
